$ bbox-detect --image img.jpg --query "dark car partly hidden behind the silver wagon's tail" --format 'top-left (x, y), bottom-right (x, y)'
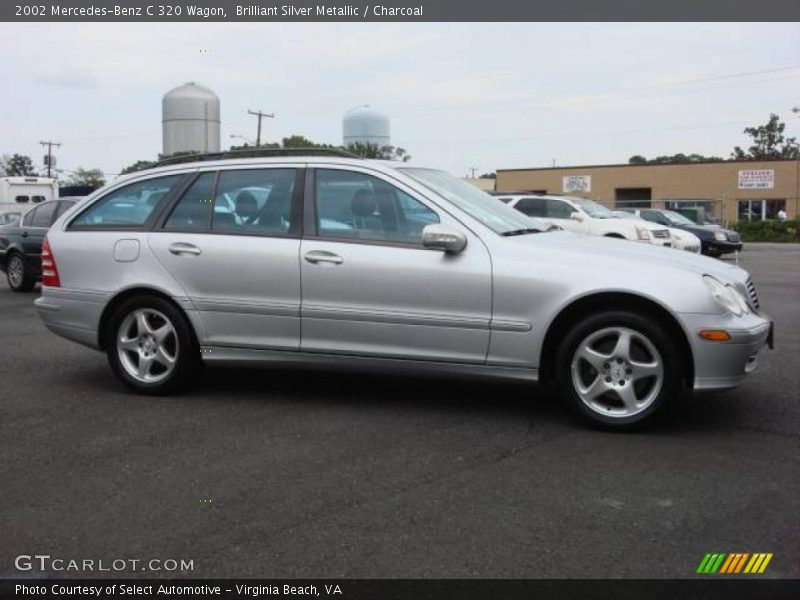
top-left (0, 198), bottom-right (78, 292)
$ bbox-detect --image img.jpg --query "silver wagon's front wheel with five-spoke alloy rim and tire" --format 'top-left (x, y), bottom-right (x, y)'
top-left (557, 311), bottom-right (683, 429)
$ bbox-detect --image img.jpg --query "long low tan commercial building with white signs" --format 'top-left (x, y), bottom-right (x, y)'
top-left (496, 160), bottom-right (800, 222)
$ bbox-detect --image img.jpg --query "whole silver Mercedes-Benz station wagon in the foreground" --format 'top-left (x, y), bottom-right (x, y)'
top-left (36, 152), bottom-right (772, 428)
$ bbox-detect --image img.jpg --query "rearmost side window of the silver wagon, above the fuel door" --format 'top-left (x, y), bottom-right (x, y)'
top-left (70, 175), bottom-right (183, 229)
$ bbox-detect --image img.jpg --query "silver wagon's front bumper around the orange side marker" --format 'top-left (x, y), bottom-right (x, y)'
top-left (682, 314), bottom-right (774, 391)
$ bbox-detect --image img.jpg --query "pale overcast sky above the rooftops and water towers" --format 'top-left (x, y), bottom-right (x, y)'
top-left (0, 23), bottom-right (800, 178)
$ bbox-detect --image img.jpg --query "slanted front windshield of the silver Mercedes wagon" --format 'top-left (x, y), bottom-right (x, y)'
top-left (400, 167), bottom-right (548, 235)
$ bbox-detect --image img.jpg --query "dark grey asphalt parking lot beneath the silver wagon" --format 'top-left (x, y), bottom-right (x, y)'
top-left (0, 245), bottom-right (800, 578)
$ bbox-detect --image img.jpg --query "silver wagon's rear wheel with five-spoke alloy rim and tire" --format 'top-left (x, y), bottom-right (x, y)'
top-left (105, 296), bottom-right (200, 394)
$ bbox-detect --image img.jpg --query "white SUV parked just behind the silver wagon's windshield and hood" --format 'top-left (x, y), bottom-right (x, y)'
top-left (499, 194), bottom-right (672, 247)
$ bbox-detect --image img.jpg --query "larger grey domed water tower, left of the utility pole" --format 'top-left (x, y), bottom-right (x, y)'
top-left (161, 81), bottom-right (220, 156)
